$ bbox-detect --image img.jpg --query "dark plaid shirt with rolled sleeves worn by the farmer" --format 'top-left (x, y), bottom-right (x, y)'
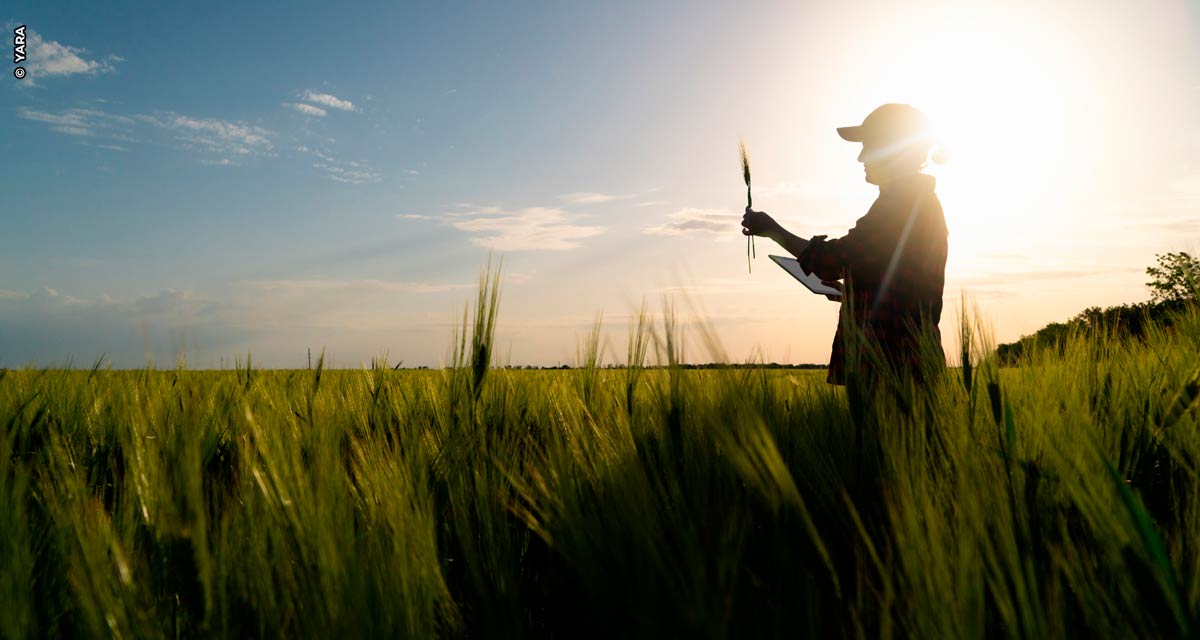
top-left (799, 174), bottom-right (948, 384)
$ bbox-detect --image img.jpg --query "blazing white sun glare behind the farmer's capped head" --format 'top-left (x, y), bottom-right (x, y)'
top-left (840, 10), bottom-right (1091, 249)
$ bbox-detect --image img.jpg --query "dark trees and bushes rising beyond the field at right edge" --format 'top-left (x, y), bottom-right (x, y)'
top-left (996, 251), bottom-right (1200, 365)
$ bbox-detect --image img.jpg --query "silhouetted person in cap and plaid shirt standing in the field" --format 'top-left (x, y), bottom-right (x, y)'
top-left (742, 104), bottom-right (947, 384)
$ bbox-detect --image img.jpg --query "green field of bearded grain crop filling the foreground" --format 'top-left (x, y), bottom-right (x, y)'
top-left (0, 276), bottom-right (1200, 638)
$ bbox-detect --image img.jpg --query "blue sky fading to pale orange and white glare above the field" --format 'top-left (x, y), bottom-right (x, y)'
top-left (0, 0), bottom-right (1200, 367)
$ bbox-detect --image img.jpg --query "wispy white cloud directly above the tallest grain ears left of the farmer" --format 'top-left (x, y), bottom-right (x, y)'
top-left (454, 207), bottom-right (606, 251)
